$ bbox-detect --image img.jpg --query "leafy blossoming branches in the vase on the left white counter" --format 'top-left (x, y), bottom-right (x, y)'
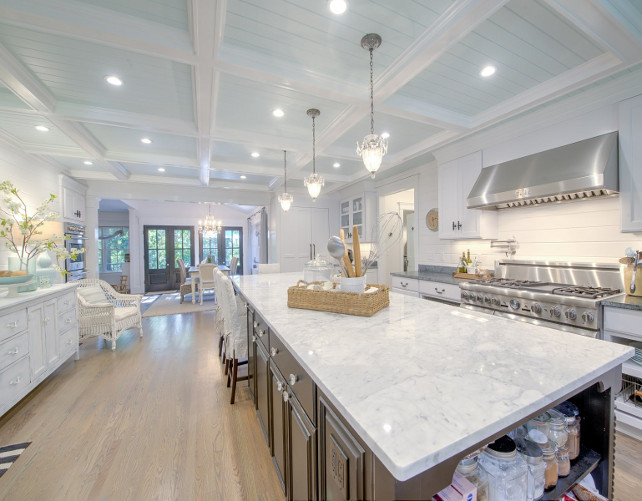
top-left (0, 181), bottom-right (85, 275)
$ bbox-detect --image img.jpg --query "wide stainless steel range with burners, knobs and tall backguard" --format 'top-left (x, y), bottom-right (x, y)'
top-left (460, 260), bottom-right (621, 337)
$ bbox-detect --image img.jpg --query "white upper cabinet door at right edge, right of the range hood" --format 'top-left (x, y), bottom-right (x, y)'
top-left (619, 96), bottom-right (642, 232)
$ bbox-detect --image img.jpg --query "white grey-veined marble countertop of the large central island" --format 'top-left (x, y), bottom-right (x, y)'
top-left (233, 273), bottom-right (634, 481)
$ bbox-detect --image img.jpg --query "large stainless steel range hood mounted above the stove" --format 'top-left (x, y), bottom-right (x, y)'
top-left (467, 132), bottom-right (619, 209)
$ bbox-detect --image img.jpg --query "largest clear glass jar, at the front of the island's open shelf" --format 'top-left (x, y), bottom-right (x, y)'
top-left (479, 435), bottom-right (528, 501)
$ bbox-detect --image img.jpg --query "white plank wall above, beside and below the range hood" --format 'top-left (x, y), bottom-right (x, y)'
top-left (417, 106), bottom-right (642, 268)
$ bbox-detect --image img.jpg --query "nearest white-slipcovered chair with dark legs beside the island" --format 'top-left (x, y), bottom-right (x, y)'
top-left (219, 277), bottom-right (248, 404)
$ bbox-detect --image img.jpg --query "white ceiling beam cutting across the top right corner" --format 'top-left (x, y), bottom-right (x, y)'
top-left (546, 0), bottom-right (642, 63)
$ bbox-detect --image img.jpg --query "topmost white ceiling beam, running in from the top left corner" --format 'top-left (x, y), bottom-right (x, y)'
top-left (0, 0), bottom-right (195, 65)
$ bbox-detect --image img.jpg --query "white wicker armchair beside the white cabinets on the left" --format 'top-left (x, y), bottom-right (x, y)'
top-left (76, 278), bottom-right (143, 350)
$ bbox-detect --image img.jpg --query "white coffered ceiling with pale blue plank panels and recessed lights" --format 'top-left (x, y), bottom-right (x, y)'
top-left (0, 0), bottom-right (642, 199)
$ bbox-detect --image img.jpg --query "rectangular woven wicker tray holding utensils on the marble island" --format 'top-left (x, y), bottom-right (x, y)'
top-left (288, 281), bottom-right (390, 317)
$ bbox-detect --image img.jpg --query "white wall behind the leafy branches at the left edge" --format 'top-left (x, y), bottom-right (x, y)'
top-left (0, 142), bottom-right (64, 282)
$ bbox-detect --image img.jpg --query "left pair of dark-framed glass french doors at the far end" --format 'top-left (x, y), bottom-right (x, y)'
top-left (144, 226), bottom-right (194, 292)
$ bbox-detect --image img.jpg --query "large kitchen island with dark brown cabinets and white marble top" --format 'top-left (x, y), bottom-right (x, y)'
top-left (233, 273), bottom-right (633, 499)
